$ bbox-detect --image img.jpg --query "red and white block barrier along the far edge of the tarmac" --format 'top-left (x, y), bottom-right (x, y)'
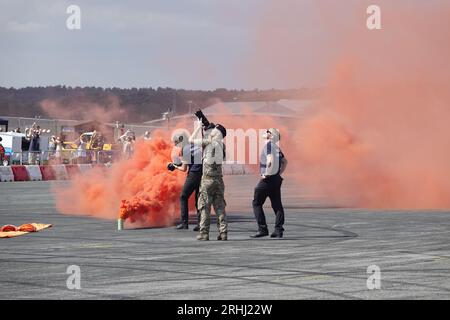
top-left (0, 164), bottom-right (253, 182)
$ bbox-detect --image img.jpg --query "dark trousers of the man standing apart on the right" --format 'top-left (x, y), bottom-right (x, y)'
top-left (253, 174), bottom-right (284, 231)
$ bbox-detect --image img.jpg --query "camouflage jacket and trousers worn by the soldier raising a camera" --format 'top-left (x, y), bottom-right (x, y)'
top-left (198, 142), bottom-right (228, 237)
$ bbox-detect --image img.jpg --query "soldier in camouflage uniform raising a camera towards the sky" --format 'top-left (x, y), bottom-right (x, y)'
top-left (192, 120), bottom-right (228, 241)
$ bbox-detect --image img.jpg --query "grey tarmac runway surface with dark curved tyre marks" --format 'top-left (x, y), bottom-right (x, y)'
top-left (0, 176), bottom-right (450, 299)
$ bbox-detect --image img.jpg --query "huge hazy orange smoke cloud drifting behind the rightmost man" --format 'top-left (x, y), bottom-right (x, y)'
top-left (248, 0), bottom-right (450, 208)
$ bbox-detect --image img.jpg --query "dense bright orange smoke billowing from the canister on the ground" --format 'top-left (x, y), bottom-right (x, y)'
top-left (55, 131), bottom-right (185, 226)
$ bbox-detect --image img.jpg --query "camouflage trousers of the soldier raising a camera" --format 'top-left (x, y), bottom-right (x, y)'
top-left (198, 176), bottom-right (228, 234)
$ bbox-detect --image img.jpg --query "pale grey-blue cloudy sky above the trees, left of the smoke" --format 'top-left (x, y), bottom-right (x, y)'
top-left (0, 0), bottom-right (268, 88)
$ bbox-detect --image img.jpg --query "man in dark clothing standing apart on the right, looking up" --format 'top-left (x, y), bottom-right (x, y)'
top-left (250, 128), bottom-right (287, 238)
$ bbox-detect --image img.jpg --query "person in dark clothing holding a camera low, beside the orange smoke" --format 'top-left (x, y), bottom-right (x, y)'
top-left (168, 132), bottom-right (203, 231)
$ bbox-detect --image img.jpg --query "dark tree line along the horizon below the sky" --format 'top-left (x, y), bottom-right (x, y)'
top-left (0, 86), bottom-right (320, 123)
